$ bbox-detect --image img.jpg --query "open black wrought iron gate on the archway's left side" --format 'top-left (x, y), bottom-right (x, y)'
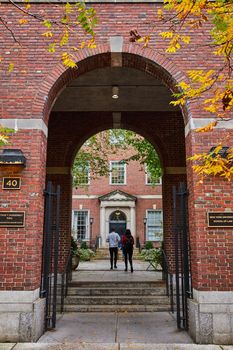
top-left (40, 182), bottom-right (60, 330)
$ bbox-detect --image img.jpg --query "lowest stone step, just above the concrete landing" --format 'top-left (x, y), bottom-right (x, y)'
top-left (64, 304), bottom-right (170, 312)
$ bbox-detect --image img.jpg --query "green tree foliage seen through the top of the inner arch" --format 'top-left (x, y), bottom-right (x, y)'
top-left (72, 129), bottom-right (161, 187)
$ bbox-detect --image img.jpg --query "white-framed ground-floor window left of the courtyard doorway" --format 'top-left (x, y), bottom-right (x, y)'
top-left (72, 210), bottom-right (89, 241)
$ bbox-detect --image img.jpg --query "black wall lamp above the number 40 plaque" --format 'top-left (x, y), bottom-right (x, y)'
top-left (0, 149), bottom-right (26, 169)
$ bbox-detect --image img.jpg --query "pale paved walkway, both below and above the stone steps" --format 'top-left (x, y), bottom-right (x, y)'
top-left (0, 260), bottom-right (233, 350)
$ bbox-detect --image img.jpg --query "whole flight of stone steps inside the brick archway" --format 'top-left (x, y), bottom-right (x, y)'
top-left (64, 281), bottom-right (170, 312)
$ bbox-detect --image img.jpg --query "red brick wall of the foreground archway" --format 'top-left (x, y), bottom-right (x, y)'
top-left (0, 3), bottom-right (233, 290)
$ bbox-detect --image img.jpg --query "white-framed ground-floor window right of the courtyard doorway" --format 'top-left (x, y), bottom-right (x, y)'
top-left (146, 209), bottom-right (163, 241)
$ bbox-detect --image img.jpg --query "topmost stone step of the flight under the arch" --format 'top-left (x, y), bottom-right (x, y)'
top-left (69, 280), bottom-right (165, 289)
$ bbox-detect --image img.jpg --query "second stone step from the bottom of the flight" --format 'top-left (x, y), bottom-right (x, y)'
top-left (65, 295), bottom-right (169, 305)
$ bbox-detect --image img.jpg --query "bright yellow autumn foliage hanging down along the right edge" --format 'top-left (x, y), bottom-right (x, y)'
top-left (130, 0), bottom-right (233, 180)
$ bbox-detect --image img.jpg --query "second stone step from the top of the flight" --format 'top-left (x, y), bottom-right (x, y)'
top-left (68, 287), bottom-right (166, 296)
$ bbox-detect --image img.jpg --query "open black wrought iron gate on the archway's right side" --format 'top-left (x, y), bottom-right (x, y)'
top-left (173, 183), bottom-right (192, 330)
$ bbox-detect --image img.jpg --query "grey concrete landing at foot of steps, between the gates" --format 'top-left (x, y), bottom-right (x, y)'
top-left (39, 312), bottom-right (192, 344)
